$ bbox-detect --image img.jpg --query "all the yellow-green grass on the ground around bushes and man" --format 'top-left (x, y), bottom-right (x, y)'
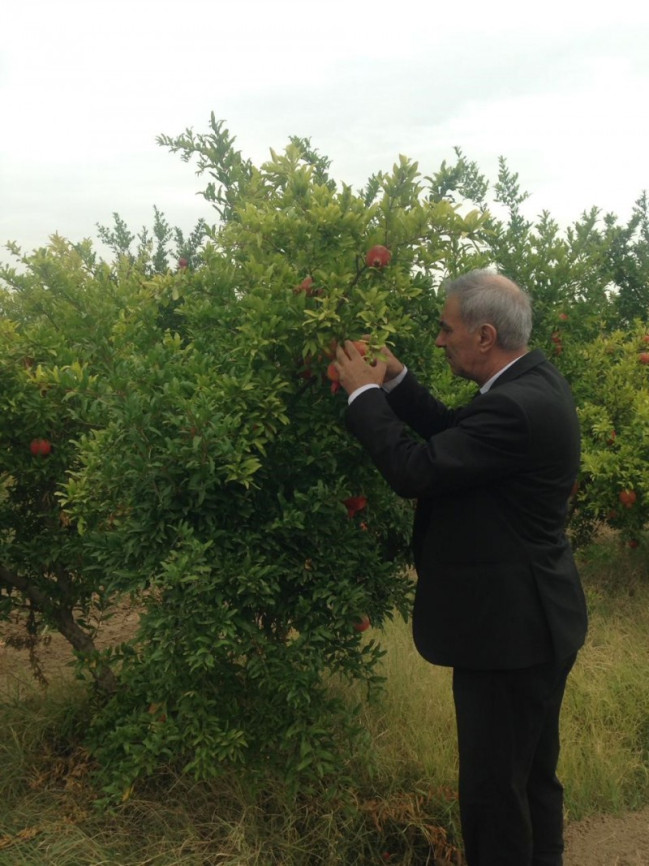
top-left (0, 541), bottom-right (649, 866)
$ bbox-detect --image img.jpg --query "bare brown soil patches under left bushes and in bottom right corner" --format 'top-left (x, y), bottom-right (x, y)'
top-left (0, 609), bottom-right (649, 866)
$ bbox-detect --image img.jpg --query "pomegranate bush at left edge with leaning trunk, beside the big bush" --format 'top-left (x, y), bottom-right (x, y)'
top-left (0, 236), bottom-right (137, 690)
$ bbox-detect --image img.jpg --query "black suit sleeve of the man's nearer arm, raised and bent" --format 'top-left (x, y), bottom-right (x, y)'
top-left (346, 389), bottom-right (529, 499)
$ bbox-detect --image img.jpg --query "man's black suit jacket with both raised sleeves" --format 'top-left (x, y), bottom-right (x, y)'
top-left (347, 350), bottom-right (587, 669)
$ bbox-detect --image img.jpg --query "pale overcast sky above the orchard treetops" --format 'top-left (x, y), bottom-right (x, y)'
top-left (0, 0), bottom-right (649, 261)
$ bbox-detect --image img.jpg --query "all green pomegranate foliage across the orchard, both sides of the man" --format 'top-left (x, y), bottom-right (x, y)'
top-left (0, 116), bottom-right (649, 799)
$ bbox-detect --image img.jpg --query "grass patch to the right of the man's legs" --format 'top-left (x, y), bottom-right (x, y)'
top-left (561, 543), bottom-right (649, 818)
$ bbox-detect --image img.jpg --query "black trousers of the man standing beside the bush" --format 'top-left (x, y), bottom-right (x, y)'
top-left (453, 656), bottom-right (575, 866)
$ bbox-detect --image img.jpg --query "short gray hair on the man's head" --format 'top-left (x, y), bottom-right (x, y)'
top-left (445, 270), bottom-right (532, 351)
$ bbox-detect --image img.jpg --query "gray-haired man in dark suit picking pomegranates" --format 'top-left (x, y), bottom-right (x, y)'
top-left (336, 271), bottom-right (587, 866)
